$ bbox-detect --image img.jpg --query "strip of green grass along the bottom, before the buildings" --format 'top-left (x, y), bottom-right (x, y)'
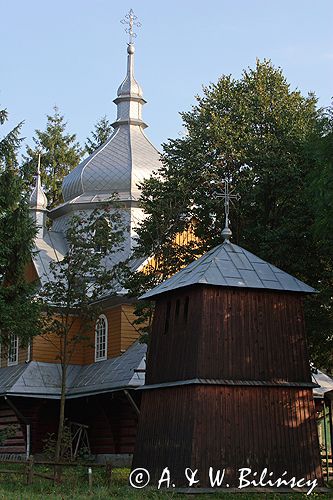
top-left (0, 463), bottom-right (333, 500)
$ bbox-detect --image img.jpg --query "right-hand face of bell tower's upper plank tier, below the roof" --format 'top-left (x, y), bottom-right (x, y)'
top-left (198, 287), bottom-right (311, 382)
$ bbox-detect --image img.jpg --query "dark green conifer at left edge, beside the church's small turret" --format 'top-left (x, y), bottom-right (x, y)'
top-left (0, 106), bottom-right (40, 346)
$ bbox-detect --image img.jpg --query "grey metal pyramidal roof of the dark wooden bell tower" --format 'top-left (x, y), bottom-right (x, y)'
top-left (140, 241), bottom-right (315, 299)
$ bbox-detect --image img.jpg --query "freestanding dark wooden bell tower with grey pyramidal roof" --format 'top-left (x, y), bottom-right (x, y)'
top-left (133, 205), bottom-right (322, 487)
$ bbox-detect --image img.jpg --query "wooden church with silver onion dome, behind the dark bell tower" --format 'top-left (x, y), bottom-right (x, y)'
top-left (0, 11), bottom-right (160, 463)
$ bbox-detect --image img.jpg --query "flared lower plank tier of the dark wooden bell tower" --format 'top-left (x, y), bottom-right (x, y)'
top-left (133, 386), bottom-right (321, 486)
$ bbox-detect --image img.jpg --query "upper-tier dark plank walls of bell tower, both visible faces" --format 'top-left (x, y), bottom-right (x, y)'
top-left (146, 286), bottom-right (311, 384)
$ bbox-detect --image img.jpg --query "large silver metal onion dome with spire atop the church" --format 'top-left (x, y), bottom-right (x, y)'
top-left (62, 36), bottom-right (160, 203)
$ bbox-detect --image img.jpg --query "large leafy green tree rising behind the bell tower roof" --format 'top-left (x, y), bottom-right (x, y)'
top-left (131, 61), bottom-right (333, 368)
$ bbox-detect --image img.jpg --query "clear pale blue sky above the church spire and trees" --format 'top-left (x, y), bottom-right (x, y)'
top-left (0, 0), bottom-right (333, 154)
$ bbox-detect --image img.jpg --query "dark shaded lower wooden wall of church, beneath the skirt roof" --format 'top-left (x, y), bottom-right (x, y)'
top-left (0, 392), bottom-right (140, 454)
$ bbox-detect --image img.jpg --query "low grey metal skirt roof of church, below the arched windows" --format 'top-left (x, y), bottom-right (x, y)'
top-left (0, 342), bottom-right (146, 399)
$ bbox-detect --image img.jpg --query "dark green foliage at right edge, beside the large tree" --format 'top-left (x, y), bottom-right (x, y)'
top-left (306, 102), bottom-right (333, 372)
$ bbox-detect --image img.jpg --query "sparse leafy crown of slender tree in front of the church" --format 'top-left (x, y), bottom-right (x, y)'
top-left (40, 202), bottom-right (124, 332)
